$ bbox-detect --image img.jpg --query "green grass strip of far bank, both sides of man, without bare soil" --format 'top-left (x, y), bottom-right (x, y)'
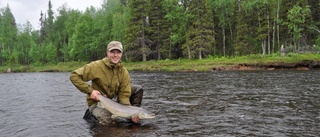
top-left (0, 53), bottom-right (320, 72)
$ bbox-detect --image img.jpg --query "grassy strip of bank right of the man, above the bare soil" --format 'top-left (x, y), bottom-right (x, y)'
top-left (126, 54), bottom-right (320, 71)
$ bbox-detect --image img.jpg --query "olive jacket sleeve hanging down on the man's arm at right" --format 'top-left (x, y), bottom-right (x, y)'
top-left (119, 71), bottom-right (131, 105)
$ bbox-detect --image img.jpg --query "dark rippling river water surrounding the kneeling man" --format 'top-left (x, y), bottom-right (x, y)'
top-left (0, 71), bottom-right (320, 137)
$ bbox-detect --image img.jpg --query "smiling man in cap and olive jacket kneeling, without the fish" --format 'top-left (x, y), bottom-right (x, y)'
top-left (70, 41), bottom-right (143, 123)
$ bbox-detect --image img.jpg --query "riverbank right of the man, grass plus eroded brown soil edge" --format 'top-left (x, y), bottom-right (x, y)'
top-left (126, 54), bottom-right (320, 71)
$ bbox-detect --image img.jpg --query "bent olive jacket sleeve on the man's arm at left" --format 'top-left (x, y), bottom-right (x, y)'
top-left (70, 65), bottom-right (93, 95)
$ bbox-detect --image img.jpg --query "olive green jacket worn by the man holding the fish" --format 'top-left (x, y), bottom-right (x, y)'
top-left (70, 58), bottom-right (131, 106)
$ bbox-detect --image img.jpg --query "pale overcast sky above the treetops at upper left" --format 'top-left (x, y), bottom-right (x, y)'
top-left (0, 0), bottom-right (103, 29)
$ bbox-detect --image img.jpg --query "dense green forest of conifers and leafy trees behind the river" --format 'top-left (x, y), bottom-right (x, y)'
top-left (0, 0), bottom-right (320, 66)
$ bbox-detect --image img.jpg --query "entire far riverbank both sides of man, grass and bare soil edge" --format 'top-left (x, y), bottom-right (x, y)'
top-left (0, 54), bottom-right (320, 73)
